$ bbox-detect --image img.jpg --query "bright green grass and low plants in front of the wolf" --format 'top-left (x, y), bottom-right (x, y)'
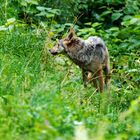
top-left (0, 29), bottom-right (140, 140)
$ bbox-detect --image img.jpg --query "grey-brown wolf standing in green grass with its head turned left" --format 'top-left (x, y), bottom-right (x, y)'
top-left (49, 28), bottom-right (110, 92)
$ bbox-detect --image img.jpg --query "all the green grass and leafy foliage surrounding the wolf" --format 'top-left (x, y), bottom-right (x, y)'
top-left (0, 0), bottom-right (140, 140)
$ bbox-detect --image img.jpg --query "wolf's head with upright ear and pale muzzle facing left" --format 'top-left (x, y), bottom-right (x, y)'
top-left (49, 28), bottom-right (75, 55)
